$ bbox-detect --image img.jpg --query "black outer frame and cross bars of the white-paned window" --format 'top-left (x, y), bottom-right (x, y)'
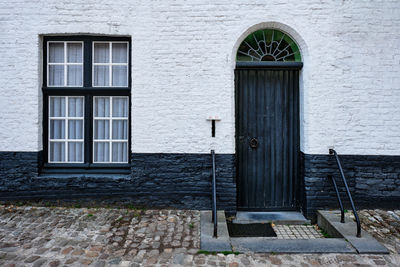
top-left (41, 35), bottom-right (132, 174)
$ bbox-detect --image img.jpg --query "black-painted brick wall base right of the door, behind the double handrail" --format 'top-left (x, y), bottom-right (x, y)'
top-left (302, 154), bottom-right (400, 220)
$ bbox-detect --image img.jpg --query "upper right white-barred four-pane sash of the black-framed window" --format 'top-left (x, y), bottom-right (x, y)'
top-left (92, 42), bottom-right (128, 87)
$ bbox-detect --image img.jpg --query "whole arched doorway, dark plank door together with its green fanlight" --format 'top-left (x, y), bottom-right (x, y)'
top-left (235, 29), bottom-right (303, 210)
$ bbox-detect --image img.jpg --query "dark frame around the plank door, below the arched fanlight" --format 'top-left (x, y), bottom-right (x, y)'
top-left (234, 61), bottom-right (303, 211)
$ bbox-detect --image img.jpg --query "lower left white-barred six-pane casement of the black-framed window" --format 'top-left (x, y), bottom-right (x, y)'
top-left (48, 96), bottom-right (84, 163)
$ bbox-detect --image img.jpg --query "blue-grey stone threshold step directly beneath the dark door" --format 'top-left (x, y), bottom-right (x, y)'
top-left (232, 211), bottom-right (311, 224)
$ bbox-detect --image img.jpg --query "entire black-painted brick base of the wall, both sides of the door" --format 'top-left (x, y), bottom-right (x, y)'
top-left (0, 152), bottom-right (400, 217)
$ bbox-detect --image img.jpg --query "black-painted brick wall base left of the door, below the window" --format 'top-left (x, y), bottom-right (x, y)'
top-left (0, 152), bottom-right (236, 212)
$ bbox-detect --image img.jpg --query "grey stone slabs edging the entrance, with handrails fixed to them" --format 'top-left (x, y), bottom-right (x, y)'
top-left (200, 211), bottom-right (388, 254)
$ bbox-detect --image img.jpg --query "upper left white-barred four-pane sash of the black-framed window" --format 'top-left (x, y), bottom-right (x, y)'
top-left (47, 41), bottom-right (83, 87)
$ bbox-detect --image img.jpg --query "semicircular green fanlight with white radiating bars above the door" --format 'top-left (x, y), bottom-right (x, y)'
top-left (236, 29), bottom-right (301, 62)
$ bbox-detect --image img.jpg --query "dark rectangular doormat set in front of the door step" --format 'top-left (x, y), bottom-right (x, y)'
top-left (227, 222), bottom-right (276, 237)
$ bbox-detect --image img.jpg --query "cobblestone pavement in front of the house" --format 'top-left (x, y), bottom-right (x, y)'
top-left (0, 205), bottom-right (400, 267)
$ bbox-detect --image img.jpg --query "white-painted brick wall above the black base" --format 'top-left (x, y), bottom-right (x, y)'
top-left (0, 0), bottom-right (400, 155)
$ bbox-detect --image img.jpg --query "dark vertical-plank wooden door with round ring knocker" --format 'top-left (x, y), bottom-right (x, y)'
top-left (235, 66), bottom-right (300, 210)
